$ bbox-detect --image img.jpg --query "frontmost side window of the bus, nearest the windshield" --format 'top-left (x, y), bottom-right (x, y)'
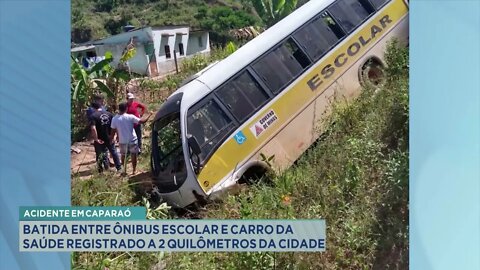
top-left (187, 99), bottom-right (234, 161)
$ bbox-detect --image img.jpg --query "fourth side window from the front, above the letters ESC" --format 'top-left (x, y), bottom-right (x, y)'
top-left (294, 12), bottom-right (344, 61)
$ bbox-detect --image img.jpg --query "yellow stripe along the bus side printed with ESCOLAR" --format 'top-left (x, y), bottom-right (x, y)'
top-left (198, 0), bottom-right (408, 194)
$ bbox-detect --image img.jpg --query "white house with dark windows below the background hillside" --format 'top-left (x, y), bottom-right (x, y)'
top-left (71, 26), bottom-right (210, 76)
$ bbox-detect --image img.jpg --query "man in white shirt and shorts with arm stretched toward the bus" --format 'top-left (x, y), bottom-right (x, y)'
top-left (111, 103), bottom-right (150, 175)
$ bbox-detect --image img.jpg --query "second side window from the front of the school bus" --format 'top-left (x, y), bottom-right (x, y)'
top-left (217, 71), bottom-right (268, 122)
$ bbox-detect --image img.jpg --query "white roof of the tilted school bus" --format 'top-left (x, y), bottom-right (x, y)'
top-left (178, 0), bottom-right (335, 107)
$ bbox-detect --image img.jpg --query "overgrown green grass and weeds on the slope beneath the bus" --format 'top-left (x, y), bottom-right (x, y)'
top-left (72, 42), bottom-right (409, 269)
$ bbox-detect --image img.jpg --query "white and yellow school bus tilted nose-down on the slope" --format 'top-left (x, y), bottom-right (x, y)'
top-left (151, 0), bottom-right (408, 207)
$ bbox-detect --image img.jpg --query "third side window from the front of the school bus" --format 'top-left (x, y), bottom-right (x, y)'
top-left (252, 38), bottom-right (310, 94)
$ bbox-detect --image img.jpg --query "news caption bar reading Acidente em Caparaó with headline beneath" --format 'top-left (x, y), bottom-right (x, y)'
top-left (19, 207), bottom-right (326, 252)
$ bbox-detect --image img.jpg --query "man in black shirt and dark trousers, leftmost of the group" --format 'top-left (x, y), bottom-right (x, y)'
top-left (90, 102), bottom-right (122, 172)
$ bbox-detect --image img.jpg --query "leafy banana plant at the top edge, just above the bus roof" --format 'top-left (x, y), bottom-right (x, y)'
top-left (249, 0), bottom-right (298, 27)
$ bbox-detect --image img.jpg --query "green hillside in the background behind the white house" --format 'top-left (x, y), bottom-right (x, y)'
top-left (71, 0), bottom-right (308, 43)
